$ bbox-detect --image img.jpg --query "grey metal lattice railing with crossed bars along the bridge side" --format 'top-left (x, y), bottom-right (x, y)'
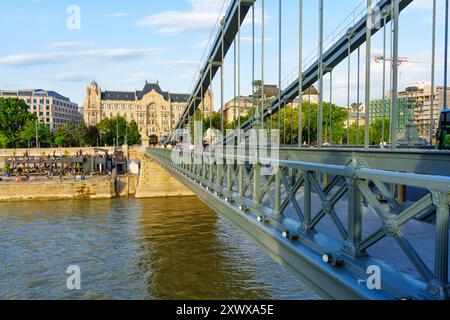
top-left (149, 149), bottom-right (450, 298)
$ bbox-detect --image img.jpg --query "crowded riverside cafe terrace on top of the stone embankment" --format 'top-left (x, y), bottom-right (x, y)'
top-left (5, 148), bottom-right (126, 181)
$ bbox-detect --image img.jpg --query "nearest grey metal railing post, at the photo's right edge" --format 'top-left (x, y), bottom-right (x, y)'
top-left (427, 190), bottom-right (450, 299)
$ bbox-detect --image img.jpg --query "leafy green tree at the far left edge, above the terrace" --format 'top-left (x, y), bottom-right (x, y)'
top-left (0, 98), bottom-right (35, 148)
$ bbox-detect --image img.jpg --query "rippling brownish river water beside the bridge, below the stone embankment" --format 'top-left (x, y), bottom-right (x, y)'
top-left (0, 198), bottom-right (317, 299)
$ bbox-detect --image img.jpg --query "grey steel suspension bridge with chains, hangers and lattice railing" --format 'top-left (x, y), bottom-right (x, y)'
top-left (147, 0), bottom-right (450, 299)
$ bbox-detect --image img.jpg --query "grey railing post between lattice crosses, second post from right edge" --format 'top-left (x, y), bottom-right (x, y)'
top-left (343, 178), bottom-right (364, 258)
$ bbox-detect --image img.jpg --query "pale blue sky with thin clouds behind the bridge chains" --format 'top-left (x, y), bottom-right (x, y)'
top-left (0, 0), bottom-right (445, 109)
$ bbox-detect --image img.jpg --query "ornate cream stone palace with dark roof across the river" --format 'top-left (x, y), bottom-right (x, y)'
top-left (84, 81), bottom-right (213, 144)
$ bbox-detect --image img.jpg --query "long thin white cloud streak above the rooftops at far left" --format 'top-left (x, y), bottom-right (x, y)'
top-left (0, 48), bottom-right (163, 65)
